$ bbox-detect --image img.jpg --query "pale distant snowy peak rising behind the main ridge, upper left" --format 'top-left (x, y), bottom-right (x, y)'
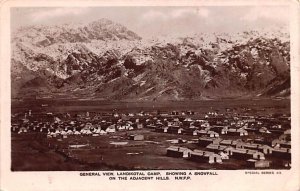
top-left (12, 18), bottom-right (141, 47)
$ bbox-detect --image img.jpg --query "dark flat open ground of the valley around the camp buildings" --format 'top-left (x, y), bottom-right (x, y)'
top-left (11, 100), bottom-right (290, 171)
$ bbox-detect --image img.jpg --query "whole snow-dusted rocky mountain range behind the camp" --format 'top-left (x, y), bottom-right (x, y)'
top-left (11, 19), bottom-right (290, 100)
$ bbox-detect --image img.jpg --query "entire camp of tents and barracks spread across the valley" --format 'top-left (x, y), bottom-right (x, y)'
top-left (11, 111), bottom-right (291, 168)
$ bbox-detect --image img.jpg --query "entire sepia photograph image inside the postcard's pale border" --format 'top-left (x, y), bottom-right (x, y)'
top-left (10, 6), bottom-right (291, 171)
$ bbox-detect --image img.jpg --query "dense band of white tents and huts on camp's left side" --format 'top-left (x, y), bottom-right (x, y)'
top-left (11, 112), bottom-right (143, 138)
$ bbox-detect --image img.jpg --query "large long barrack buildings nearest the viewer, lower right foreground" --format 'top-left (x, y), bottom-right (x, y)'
top-left (167, 131), bottom-right (291, 168)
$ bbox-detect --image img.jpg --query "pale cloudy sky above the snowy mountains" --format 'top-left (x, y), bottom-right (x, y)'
top-left (11, 6), bottom-right (289, 37)
